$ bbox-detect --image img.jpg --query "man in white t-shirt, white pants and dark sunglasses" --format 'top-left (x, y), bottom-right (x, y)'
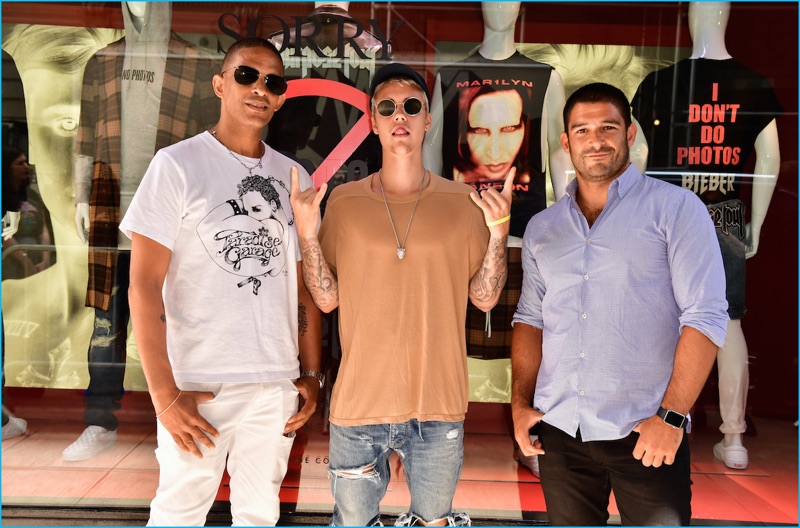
top-left (120, 38), bottom-right (324, 526)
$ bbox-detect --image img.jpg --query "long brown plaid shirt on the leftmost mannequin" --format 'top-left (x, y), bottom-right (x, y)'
top-left (76, 32), bottom-right (220, 310)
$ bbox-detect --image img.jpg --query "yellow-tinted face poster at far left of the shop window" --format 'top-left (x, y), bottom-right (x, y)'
top-left (2, 24), bottom-right (122, 387)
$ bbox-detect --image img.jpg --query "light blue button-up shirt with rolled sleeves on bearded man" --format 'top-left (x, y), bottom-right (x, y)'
top-left (512, 164), bottom-right (728, 441)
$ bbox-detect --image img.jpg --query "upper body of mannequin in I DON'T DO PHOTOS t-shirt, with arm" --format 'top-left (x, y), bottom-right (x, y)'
top-left (633, 2), bottom-right (781, 257)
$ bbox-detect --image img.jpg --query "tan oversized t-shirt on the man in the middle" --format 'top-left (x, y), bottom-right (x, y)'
top-left (319, 175), bottom-right (489, 426)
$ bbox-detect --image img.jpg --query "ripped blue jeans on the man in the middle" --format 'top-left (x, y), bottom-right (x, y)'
top-left (328, 420), bottom-right (469, 526)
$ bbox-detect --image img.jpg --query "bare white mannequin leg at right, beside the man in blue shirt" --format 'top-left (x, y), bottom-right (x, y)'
top-left (714, 319), bottom-right (750, 469)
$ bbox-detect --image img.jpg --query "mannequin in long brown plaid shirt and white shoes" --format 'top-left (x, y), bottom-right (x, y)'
top-left (62, 2), bottom-right (219, 461)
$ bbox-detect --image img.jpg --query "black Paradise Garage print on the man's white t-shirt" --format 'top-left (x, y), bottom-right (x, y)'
top-left (197, 175), bottom-right (294, 295)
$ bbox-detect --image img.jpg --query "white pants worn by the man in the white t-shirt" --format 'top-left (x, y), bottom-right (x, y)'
top-left (148, 380), bottom-right (299, 526)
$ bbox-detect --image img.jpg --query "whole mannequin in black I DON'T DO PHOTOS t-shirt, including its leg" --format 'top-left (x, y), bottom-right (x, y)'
top-left (633, 2), bottom-right (781, 469)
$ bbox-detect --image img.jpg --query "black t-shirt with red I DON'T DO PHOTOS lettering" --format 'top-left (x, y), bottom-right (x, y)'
top-left (631, 59), bottom-right (782, 204)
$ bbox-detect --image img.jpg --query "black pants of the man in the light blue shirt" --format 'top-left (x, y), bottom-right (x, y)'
top-left (538, 423), bottom-right (692, 526)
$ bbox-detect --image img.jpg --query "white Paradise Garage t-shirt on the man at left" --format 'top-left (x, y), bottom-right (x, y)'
top-left (120, 132), bottom-right (311, 384)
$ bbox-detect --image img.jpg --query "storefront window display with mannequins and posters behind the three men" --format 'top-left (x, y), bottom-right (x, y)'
top-left (2, 2), bottom-right (798, 524)
